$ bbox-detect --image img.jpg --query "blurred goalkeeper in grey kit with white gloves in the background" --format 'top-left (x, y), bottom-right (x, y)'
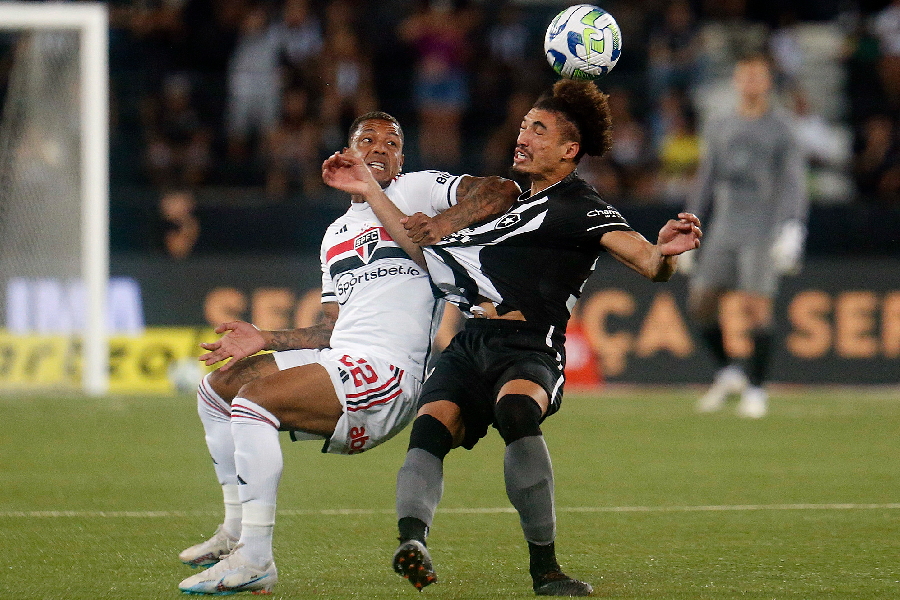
top-left (682, 54), bottom-right (809, 418)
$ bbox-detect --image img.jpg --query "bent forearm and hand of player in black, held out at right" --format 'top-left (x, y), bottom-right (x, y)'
top-left (601, 213), bottom-right (703, 281)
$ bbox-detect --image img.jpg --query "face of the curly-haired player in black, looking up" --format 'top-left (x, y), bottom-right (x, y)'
top-left (512, 108), bottom-right (578, 179)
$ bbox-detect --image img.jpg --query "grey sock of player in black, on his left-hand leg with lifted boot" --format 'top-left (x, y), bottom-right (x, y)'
top-left (397, 448), bottom-right (444, 527)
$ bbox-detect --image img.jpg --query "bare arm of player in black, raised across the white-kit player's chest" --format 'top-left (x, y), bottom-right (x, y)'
top-left (322, 151), bottom-right (428, 269)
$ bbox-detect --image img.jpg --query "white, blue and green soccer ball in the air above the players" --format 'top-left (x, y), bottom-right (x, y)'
top-left (544, 4), bottom-right (622, 79)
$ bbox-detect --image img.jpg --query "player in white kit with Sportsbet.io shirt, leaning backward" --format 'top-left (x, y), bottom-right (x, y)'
top-left (179, 112), bottom-right (519, 594)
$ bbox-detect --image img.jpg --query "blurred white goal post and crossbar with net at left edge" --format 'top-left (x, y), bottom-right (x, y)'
top-left (0, 2), bottom-right (109, 395)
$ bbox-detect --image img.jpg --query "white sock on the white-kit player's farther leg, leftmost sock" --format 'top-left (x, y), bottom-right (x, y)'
top-left (197, 375), bottom-right (241, 538)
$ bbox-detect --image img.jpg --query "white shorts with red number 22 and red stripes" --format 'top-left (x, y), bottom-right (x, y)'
top-left (273, 348), bottom-right (422, 454)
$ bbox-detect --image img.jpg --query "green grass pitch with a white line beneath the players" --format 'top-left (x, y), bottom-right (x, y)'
top-left (0, 388), bottom-right (900, 600)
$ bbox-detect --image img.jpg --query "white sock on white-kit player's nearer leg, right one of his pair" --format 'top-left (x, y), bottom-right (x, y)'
top-left (231, 398), bottom-right (284, 567)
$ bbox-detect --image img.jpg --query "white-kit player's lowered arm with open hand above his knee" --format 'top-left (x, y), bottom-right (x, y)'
top-left (199, 302), bottom-right (340, 371)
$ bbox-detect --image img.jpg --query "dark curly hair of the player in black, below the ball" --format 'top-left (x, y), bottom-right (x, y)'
top-left (534, 79), bottom-right (612, 162)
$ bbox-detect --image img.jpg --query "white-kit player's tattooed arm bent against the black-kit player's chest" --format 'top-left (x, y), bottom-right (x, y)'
top-left (401, 175), bottom-right (522, 246)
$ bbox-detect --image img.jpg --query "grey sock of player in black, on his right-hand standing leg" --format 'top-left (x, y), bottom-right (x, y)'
top-left (503, 435), bottom-right (556, 544)
